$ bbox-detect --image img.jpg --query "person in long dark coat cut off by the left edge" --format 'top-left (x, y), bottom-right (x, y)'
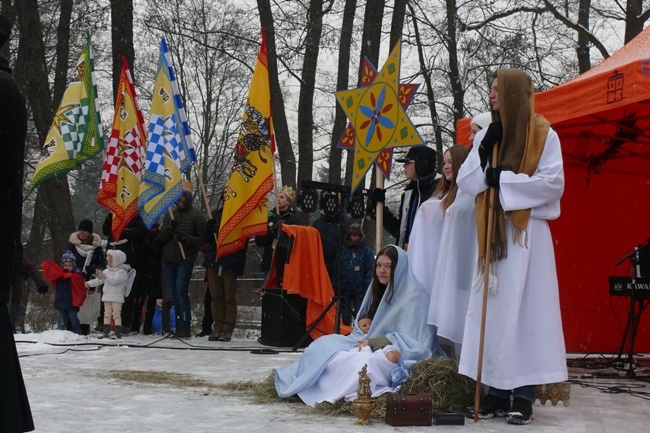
top-left (0, 15), bottom-right (34, 432)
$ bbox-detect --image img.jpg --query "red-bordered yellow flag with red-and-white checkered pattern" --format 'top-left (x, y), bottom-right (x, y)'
top-left (97, 57), bottom-right (146, 240)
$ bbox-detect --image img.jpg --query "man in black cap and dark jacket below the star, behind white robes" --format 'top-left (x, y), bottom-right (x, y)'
top-left (370, 146), bottom-right (437, 250)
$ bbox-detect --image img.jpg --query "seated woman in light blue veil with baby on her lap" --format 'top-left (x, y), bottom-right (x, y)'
top-left (275, 245), bottom-right (439, 406)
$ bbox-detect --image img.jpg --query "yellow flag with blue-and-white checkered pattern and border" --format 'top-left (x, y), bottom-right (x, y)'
top-left (138, 38), bottom-right (189, 228)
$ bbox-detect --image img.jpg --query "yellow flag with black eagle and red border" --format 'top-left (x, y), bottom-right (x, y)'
top-left (217, 30), bottom-right (275, 257)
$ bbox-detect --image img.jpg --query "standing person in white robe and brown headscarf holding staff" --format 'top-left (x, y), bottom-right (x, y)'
top-left (458, 69), bottom-right (568, 424)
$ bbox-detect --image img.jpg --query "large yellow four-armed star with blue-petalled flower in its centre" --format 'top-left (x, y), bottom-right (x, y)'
top-left (335, 41), bottom-right (424, 191)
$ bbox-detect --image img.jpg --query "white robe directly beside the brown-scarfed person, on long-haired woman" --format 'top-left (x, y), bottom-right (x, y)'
top-left (427, 189), bottom-right (478, 344)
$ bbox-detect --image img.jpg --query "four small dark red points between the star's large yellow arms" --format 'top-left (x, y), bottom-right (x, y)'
top-left (337, 58), bottom-right (420, 179)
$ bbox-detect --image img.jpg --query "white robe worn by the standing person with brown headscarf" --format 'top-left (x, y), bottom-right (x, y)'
top-left (458, 129), bottom-right (568, 390)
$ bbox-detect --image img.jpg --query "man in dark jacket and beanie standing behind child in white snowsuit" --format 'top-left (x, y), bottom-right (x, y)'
top-left (160, 181), bottom-right (207, 338)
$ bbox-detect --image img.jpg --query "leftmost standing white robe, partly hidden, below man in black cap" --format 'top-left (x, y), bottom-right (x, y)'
top-left (406, 197), bottom-right (442, 293)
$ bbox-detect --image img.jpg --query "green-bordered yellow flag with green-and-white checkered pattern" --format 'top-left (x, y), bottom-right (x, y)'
top-left (27, 34), bottom-right (104, 194)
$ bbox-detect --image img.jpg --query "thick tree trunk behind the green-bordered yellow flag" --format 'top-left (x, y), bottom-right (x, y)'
top-left (16, 0), bottom-right (74, 257)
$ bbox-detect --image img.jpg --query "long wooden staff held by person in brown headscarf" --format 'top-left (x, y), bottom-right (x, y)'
top-left (474, 143), bottom-right (499, 422)
